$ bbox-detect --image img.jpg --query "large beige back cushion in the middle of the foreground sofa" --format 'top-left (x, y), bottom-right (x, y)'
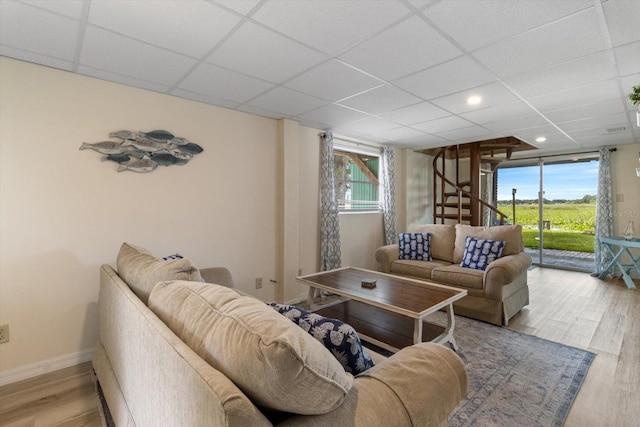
top-left (149, 281), bottom-right (353, 414)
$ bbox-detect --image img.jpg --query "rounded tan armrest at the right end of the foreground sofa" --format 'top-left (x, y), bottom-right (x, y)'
top-left (278, 343), bottom-right (468, 427)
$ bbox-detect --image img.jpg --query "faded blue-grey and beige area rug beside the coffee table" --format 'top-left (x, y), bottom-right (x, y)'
top-left (364, 312), bottom-right (595, 427)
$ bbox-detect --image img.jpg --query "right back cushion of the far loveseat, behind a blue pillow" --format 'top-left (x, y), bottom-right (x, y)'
top-left (452, 224), bottom-right (524, 264)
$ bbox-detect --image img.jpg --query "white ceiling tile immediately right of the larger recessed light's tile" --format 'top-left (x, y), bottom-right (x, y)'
top-left (505, 51), bottom-right (615, 97)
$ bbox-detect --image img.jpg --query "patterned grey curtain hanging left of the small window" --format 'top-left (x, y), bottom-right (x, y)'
top-left (320, 132), bottom-right (342, 271)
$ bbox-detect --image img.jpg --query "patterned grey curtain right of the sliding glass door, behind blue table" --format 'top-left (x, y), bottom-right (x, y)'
top-left (595, 148), bottom-right (613, 273)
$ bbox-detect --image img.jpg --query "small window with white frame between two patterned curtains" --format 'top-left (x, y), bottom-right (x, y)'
top-left (333, 148), bottom-right (381, 211)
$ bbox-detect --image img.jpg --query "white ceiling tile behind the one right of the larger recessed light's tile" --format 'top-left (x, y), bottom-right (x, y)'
top-left (528, 80), bottom-right (619, 112)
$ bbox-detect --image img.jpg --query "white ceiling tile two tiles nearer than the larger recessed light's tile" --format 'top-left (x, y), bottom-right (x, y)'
top-left (340, 17), bottom-right (462, 80)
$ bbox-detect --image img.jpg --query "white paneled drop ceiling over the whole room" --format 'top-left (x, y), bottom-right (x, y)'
top-left (0, 0), bottom-right (640, 156)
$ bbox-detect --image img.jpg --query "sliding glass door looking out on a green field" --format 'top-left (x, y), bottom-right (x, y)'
top-left (497, 157), bottom-right (598, 271)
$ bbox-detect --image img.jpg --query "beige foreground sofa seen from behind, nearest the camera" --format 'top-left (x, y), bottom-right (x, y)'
top-left (93, 243), bottom-right (467, 427)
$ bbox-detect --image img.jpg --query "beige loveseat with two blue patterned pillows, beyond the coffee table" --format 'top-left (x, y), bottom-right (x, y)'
top-left (375, 224), bottom-right (531, 326)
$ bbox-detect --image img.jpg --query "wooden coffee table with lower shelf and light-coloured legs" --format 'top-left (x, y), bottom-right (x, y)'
top-left (297, 267), bottom-right (467, 352)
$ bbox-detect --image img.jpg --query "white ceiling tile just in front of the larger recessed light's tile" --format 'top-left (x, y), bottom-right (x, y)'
top-left (395, 56), bottom-right (496, 99)
